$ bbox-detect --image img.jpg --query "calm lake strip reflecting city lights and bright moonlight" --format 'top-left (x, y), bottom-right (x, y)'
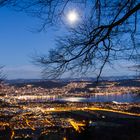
top-left (3, 93), bottom-right (140, 103)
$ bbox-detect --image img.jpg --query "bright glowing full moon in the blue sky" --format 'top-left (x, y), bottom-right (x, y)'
top-left (67, 10), bottom-right (79, 24)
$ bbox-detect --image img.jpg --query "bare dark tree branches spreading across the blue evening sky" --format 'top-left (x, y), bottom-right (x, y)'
top-left (3, 0), bottom-right (140, 79)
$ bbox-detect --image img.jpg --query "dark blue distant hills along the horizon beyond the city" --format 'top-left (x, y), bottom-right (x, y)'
top-left (6, 76), bottom-right (140, 88)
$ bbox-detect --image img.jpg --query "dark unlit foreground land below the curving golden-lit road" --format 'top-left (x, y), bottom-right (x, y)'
top-left (0, 110), bottom-right (140, 140)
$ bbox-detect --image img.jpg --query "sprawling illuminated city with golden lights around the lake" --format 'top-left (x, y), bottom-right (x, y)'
top-left (0, 81), bottom-right (140, 139)
